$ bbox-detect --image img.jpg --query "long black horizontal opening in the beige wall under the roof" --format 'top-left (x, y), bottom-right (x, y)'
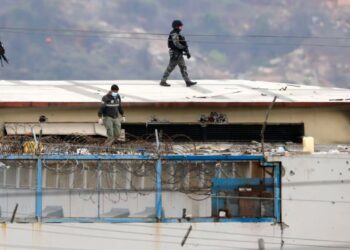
top-left (123, 123), bottom-right (304, 143)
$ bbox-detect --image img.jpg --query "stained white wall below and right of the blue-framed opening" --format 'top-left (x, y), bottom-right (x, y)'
top-left (0, 154), bottom-right (350, 250)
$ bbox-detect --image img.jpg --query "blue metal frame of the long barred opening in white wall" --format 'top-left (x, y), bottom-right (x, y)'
top-left (0, 154), bottom-right (281, 223)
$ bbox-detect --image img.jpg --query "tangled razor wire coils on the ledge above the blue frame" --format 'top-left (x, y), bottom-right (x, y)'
top-left (0, 134), bottom-right (196, 155)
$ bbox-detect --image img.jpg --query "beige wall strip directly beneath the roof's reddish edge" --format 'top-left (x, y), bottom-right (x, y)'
top-left (0, 107), bottom-right (350, 144)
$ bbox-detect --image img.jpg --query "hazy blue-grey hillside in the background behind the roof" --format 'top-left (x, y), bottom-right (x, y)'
top-left (0, 0), bottom-right (350, 87)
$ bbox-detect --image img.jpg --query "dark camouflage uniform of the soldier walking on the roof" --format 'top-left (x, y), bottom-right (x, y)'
top-left (162, 29), bottom-right (190, 82)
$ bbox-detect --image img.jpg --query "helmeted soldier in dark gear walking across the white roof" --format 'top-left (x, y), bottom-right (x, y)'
top-left (160, 20), bottom-right (197, 87)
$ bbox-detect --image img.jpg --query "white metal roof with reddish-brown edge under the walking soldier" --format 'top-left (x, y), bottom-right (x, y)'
top-left (0, 80), bottom-right (350, 107)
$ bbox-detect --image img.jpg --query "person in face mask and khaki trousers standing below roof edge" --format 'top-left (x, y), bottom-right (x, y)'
top-left (98, 84), bottom-right (125, 145)
